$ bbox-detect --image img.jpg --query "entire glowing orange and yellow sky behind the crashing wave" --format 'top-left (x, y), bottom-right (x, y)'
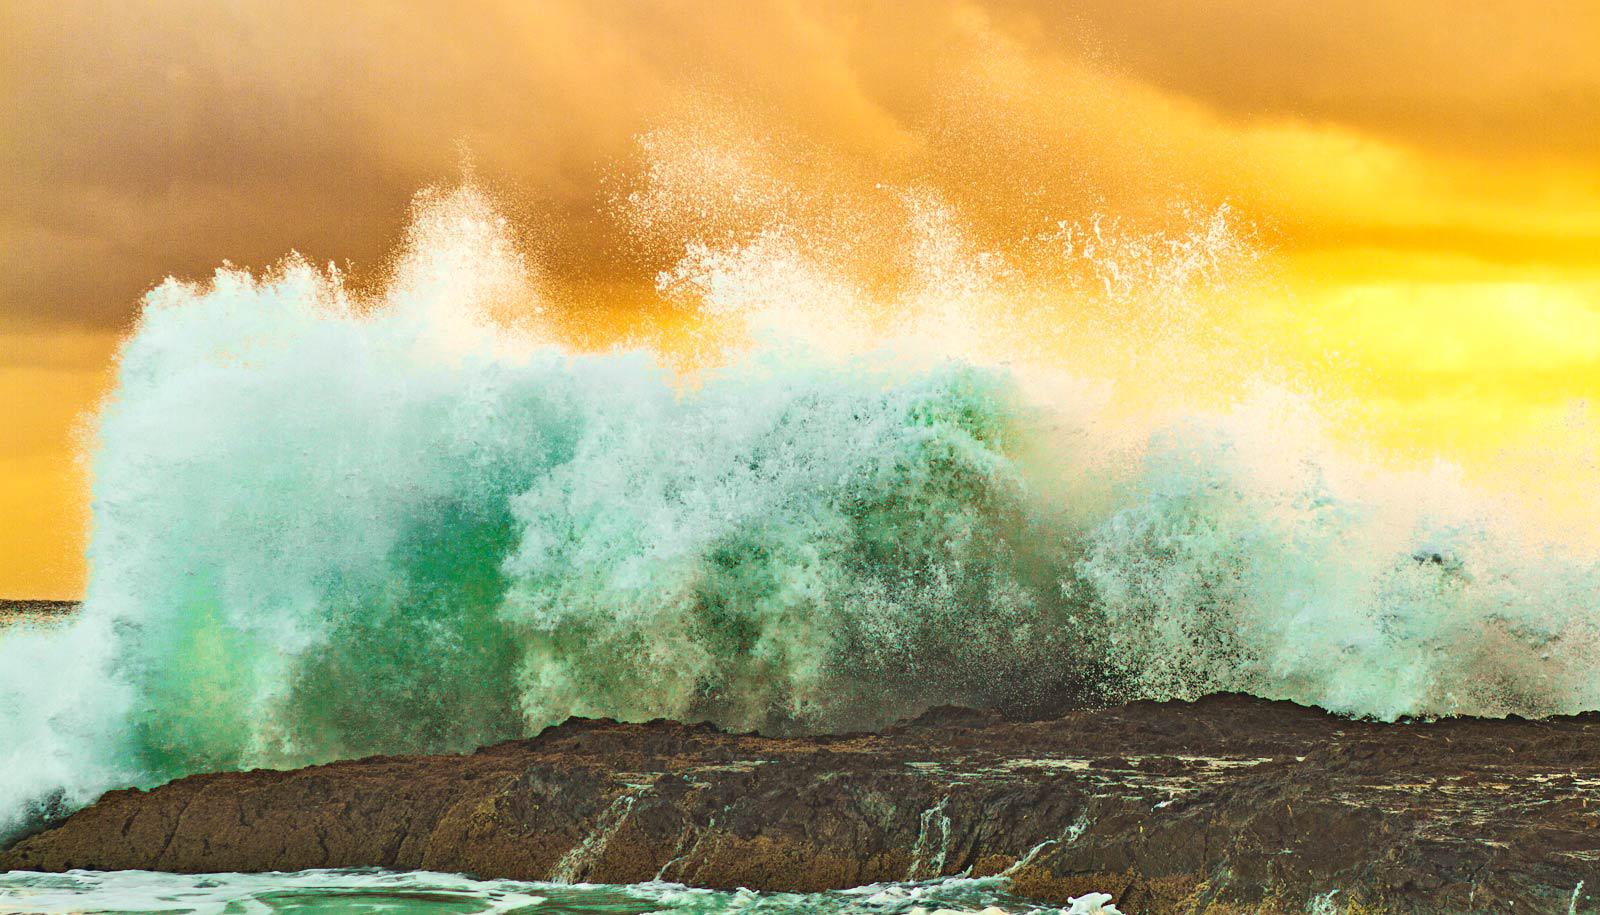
top-left (0, 0), bottom-right (1600, 597)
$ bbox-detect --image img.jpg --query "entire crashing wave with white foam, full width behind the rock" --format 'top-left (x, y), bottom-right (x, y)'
top-left (0, 153), bottom-right (1600, 832)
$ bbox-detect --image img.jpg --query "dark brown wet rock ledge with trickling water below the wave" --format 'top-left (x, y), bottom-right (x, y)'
top-left (0, 696), bottom-right (1600, 915)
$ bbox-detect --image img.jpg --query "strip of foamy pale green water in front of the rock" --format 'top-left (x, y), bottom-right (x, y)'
top-left (0, 869), bottom-right (1115, 915)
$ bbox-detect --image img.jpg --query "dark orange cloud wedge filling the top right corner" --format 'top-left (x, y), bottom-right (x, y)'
top-left (1000, 0), bottom-right (1600, 162)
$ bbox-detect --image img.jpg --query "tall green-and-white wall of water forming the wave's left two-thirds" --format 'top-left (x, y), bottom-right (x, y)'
top-left (3, 183), bottom-right (1075, 838)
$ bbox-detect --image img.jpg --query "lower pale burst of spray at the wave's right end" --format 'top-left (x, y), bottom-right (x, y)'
top-left (1075, 403), bottom-right (1600, 718)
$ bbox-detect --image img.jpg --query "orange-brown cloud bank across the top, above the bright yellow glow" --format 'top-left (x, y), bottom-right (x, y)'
top-left (0, 0), bottom-right (1600, 334)
